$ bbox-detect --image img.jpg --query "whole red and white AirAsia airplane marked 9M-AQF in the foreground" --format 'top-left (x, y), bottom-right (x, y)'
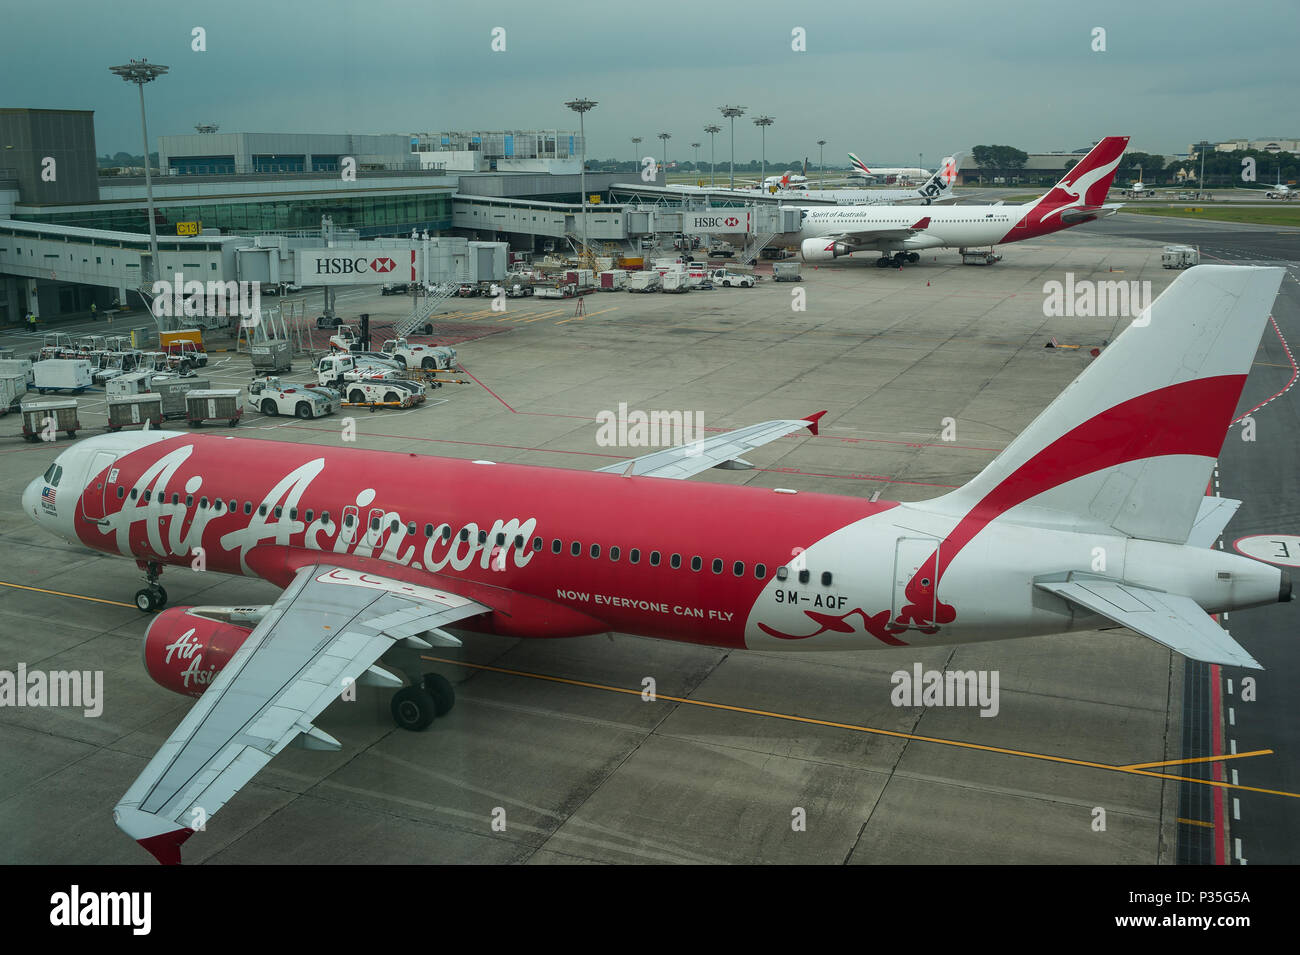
top-left (22, 265), bottom-right (1291, 863)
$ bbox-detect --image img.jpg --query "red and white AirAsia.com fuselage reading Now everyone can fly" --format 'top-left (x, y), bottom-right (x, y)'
top-left (32, 433), bottom-right (1277, 650)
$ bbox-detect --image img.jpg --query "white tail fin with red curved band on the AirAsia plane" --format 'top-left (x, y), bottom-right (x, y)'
top-left (928, 265), bottom-right (1286, 544)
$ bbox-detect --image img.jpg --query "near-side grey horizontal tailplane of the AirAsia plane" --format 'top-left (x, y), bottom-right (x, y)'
top-left (1034, 576), bottom-right (1264, 669)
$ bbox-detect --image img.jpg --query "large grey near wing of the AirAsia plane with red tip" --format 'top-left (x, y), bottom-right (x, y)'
top-left (113, 565), bottom-right (491, 864)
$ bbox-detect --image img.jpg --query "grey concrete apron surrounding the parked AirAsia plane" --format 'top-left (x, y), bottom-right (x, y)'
top-left (0, 230), bottom-right (1300, 864)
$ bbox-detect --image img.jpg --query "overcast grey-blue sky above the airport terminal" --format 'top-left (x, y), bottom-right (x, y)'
top-left (0, 0), bottom-right (1300, 165)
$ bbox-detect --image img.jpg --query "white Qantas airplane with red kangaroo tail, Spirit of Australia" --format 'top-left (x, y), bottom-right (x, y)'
top-left (800, 136), bottom-right (1128, 268)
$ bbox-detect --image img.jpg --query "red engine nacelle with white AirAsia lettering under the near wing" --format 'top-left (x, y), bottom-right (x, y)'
top-left (144, 607), bottom-right (268, 696)
